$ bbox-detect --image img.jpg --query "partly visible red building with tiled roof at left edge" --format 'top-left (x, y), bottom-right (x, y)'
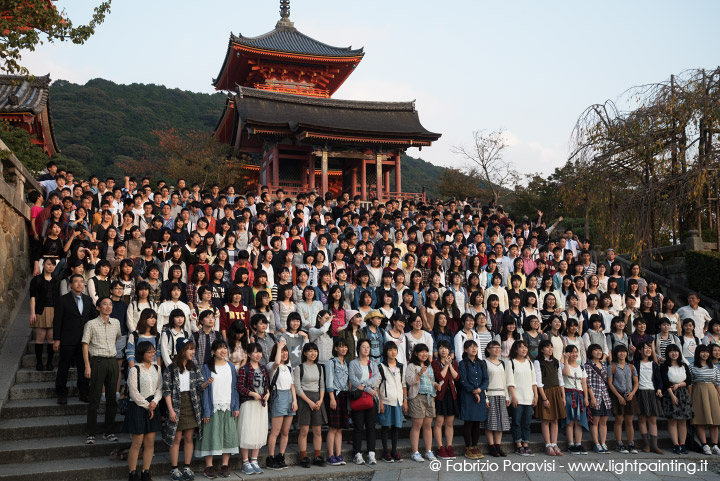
top-left (0, 74), bottom-right (60, 155)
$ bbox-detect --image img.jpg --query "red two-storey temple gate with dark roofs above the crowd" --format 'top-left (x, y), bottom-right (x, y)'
top-left (213, 0), bottom-right (440, 201)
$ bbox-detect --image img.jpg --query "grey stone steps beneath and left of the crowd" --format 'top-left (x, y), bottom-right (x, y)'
top-left (0, 342), bottom-right (704, 481)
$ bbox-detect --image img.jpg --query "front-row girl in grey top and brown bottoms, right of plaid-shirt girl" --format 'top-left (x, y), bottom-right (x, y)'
top-left (608, 344), bottom-right (638, 454)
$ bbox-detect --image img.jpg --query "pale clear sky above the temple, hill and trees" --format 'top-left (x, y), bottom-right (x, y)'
top-left (19, 0), bottom-right (720, 175)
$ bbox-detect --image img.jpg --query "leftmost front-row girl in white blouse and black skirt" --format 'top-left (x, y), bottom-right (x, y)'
top-left (122, 341), bottom-right (163, 481)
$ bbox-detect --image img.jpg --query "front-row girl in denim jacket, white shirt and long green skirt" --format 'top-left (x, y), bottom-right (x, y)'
top-left (195, 338), bottom-right (240, 479)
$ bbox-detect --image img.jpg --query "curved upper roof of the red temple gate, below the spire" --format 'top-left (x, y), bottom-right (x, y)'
top-left (230, 26), bottom-right (365, 58)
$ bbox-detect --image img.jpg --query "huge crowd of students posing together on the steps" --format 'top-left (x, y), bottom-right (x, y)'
top-left (25, 163), bottom-right (720, 481)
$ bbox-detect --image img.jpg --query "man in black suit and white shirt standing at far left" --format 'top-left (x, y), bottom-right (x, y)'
top-left (53, 274), bottom-right (98, 404)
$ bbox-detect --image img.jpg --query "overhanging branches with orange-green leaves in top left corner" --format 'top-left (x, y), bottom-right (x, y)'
top-left (0, 0), bottom-right (111, 75)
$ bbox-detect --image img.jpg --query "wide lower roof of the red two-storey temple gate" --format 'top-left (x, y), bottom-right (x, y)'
top-left (235, 87), bottom-right (441, 147)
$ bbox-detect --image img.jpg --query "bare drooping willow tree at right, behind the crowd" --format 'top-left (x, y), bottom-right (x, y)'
top-left (570, 69), bottom-right (720, 251)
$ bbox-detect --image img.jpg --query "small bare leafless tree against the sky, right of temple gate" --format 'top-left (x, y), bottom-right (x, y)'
top-left (452, 129), bottom-right (519, 203)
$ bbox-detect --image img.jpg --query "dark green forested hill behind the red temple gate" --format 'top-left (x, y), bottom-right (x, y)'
top-left (50, 79), bottom-right (445, 196)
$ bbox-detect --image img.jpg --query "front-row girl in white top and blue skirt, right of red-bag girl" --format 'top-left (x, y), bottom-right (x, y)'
top-left (378, 341), bottom-right (408, 463)
